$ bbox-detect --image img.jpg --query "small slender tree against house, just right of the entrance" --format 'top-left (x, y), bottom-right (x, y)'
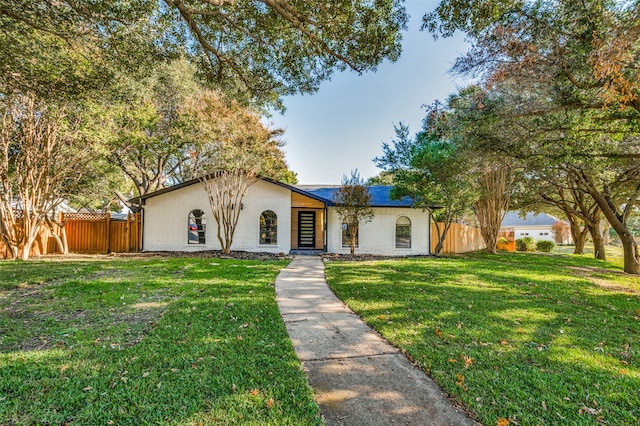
top-left (333, 169), bottom-right (375, 257)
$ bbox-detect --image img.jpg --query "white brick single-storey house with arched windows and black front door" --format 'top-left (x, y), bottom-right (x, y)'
top-left (133, 178), bottom-right (431, 255)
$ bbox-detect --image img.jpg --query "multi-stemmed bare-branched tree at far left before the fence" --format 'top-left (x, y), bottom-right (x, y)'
top-left (0, 94), bottom-right (96, 260)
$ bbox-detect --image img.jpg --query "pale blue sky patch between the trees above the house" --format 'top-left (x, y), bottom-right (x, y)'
top-left (270, 0), bottom-right (467, 184)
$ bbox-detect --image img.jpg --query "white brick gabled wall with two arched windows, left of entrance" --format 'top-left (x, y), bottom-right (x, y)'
top-left (143, 180), bottom-right (291, 253)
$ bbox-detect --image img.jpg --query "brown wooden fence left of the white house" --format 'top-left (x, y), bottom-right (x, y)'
top-left (0, 213), bottom-right (142, 257)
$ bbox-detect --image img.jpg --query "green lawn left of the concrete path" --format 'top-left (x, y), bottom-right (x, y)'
top-left (0, 258), bottom-right (322, 425)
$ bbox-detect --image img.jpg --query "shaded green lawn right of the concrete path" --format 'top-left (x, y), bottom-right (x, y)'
top-left (326, 253), bottom-right (640, 425)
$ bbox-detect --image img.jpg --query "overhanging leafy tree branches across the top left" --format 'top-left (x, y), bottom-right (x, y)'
top-left (0, 0), bottom-right (408, 107)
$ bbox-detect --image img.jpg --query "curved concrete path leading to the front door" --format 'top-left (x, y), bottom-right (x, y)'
top-left (276, 256), bottom-right (474, 426)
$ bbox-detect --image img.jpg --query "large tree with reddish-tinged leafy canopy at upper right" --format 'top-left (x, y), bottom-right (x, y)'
top-left (423, 0), bottom-right (640, 274)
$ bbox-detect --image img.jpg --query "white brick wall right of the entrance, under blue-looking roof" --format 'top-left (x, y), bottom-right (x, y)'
top-left (327, 207), bottom-right (430, 256)
